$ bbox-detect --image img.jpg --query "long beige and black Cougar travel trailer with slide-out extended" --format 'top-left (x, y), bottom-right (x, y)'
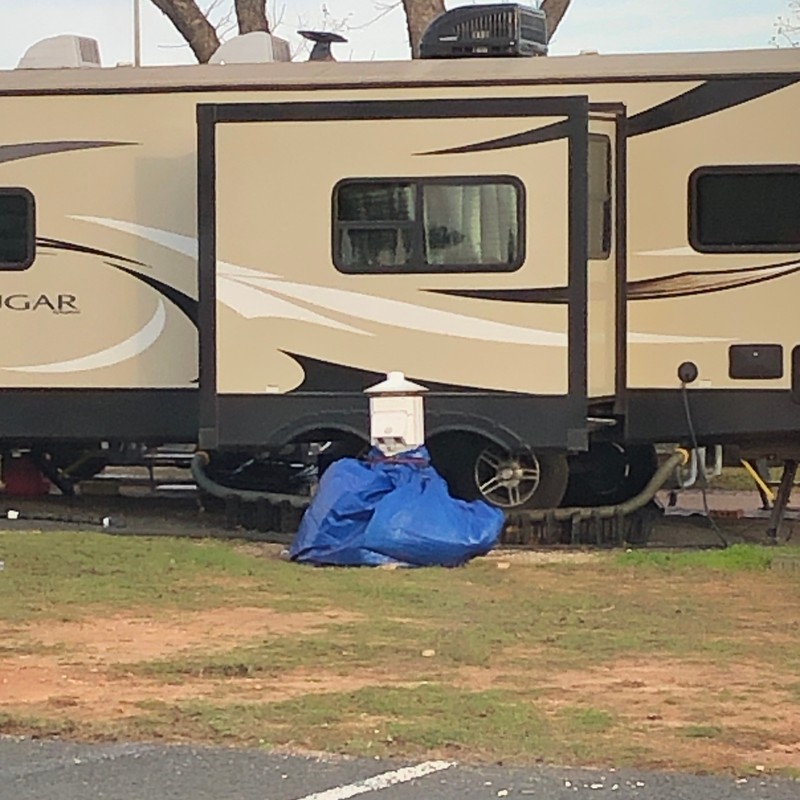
top-left (0, 12), bottom-right (800, 507)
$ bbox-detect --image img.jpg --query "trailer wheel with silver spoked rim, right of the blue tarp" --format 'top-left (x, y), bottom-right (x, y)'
top-left (429, 434), bottom-right (569, 509)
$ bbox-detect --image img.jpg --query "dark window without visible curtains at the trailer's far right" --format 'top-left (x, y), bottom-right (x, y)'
top-left (689, 165), bottom-right (800, 253)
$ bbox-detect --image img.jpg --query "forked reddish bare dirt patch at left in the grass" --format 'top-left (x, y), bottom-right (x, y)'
top-left (0, 607), bottom-right (362, 719)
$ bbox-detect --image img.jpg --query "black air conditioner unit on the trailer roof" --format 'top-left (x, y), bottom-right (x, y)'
top-left (419, 3), bottom-right (547, 58)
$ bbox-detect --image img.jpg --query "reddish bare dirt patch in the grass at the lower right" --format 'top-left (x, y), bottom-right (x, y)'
top-left (539, 659), bottom-right (800, 770)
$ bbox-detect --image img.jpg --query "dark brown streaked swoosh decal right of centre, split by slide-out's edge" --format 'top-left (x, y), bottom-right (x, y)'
top-left (427, 259), bottom-right (800, 304)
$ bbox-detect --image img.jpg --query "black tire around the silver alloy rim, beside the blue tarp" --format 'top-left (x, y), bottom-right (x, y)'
top-left (428, 434), bottom-right (569, 510)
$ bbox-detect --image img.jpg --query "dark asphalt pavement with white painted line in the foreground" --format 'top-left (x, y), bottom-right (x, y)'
top-left (0, 737), bottom-right (800, 800)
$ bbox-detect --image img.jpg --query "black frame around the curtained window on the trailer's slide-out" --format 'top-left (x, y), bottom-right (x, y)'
top-left (331, 174), bottom-right (527, 275)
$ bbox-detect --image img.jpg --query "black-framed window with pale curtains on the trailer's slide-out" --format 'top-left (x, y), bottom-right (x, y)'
top-left (333, 176), bottom-right (524, 274)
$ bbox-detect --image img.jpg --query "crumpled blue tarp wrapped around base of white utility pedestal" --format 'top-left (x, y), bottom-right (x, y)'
top-left (289, 447), bottom-right (503, 567)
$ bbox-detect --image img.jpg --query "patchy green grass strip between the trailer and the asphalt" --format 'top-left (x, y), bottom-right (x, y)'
top-left (0, 533), bottom-right (800, 766)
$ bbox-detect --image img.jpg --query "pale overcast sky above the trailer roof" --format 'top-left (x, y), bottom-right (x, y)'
top-left (0, 0), bottom-right (788, 68)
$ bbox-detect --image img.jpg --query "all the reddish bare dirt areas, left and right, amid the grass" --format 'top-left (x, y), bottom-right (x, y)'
top-left (0, 555), bottom-right (800, 770)
